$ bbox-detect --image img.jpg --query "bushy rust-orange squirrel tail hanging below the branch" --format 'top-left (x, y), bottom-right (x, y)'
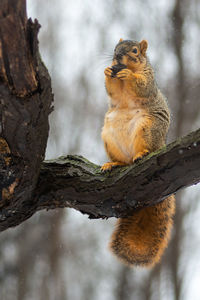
top-left (110, 195), bottom-right (175, 267)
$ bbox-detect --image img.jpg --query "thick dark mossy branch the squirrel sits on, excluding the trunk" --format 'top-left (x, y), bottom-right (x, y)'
top-left (35, 129), bottom-right (200, 218)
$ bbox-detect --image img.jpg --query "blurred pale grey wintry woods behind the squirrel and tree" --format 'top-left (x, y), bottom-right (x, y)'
top-left (0, 0), bottom-right (200, 300)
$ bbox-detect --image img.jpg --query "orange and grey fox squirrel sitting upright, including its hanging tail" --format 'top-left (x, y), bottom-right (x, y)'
top-left (101, 39), bottom-right (175, 267)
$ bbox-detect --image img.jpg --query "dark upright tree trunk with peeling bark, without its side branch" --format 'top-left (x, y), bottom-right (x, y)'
top-left (0, 0), bottom-right (53, 225)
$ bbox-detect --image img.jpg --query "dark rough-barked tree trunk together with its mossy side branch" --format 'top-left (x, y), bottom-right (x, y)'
top-left (0, 0), bottom-right (200, 231)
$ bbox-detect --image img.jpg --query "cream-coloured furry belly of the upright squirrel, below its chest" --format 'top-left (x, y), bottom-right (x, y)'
top-left (102, 108), bottom-right (147, 164)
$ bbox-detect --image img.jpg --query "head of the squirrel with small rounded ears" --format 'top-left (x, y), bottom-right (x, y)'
top-left (112, 39), bottom-right (148, 71)
